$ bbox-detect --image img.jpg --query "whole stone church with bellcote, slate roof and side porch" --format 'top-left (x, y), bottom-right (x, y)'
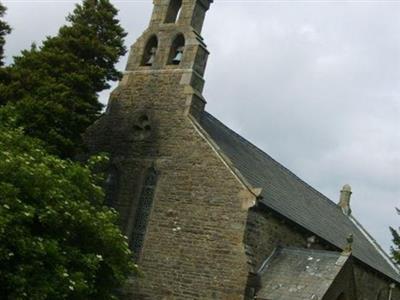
top-left (85, 0), bottom-right (400, 300)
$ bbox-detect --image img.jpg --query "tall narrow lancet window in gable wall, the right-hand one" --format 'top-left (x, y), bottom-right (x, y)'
top-left (131, 167), bottom-right (158, 261)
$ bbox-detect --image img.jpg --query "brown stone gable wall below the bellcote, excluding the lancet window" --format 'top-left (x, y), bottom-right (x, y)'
top-left (86, 70), bottom-right (255, 300)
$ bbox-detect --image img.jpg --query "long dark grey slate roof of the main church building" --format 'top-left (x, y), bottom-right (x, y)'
top-left (200, 112), bottom-right (400, 282)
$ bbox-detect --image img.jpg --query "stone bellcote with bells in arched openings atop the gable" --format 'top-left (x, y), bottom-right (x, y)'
top-left (121, 0), bottom-right (213, 119)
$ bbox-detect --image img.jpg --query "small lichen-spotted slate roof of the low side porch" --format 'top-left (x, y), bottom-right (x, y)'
top-left (255, 248), bottom-right (349, 300)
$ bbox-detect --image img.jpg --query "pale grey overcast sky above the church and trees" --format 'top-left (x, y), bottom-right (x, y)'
top-left (3, 0), bottom-right (400, 250)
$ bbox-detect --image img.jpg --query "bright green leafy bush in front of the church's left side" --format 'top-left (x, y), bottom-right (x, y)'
top-left (0, 106), bottom-right (135, 300)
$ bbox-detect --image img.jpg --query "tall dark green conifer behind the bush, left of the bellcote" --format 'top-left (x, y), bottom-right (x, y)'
top-left (0, 0), bottom-right (126, 158)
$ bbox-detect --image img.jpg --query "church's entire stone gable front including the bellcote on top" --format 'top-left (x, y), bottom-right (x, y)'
top-left (85, 0), bottom-right (254, 300)
